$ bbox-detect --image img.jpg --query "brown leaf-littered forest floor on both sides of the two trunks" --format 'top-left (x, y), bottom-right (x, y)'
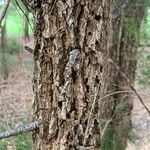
top-left (0, 49), bottom-right (150, 150)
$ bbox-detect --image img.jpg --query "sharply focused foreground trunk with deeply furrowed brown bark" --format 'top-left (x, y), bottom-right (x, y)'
top-left (33, 0), bottom-right (111, 150)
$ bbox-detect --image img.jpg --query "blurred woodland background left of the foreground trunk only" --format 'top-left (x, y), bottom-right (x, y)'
top-left (0, 0), bottom-right (34, 150)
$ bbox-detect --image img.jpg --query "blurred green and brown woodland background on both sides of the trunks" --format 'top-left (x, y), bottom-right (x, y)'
top-left (0, 0), bottom-right (150, 150)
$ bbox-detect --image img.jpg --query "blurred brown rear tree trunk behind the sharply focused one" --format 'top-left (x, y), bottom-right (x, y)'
top-left (100, 1), bottom-right (144, 150)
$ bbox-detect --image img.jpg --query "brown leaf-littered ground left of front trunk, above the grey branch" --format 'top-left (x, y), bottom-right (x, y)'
top-left (0, 52), bottom-right (33, 126)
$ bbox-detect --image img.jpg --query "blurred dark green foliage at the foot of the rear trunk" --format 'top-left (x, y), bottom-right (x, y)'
top-left (101, 123), bottom-right (137, 150)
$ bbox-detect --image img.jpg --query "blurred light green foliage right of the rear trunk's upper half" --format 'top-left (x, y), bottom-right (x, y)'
top-left (136, 0), bottom-right (150, 88)
